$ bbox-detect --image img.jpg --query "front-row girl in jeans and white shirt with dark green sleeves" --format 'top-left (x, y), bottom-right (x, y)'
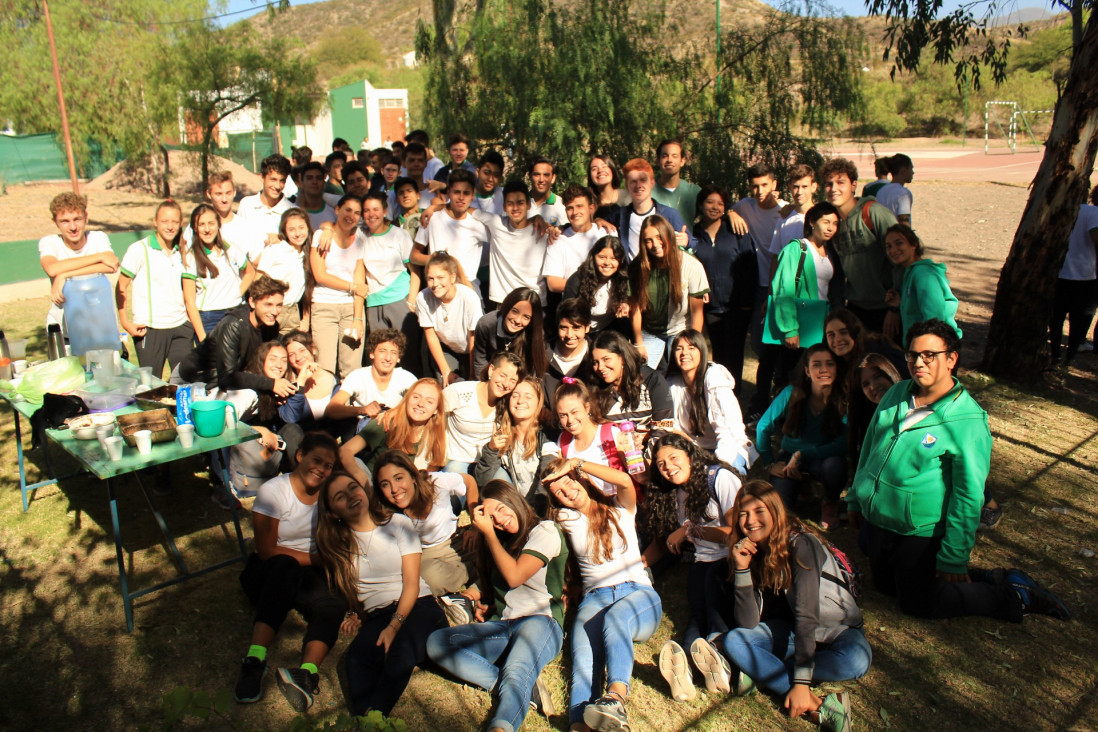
top-left (427, 481), bottom-right (568, 732)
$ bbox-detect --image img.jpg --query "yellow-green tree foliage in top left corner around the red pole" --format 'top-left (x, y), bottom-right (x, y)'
top-left (0, 0), bottom-right (206, 158)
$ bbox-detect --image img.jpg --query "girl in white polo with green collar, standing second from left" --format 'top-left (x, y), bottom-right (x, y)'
top-left (114, 201), bottom-right (194, 376)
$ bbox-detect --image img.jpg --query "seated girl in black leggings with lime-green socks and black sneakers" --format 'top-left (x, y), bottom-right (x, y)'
top-left (235, 432), bottom-right (346, 712)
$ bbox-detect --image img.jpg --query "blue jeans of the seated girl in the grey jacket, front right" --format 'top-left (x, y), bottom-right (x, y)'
top-left (720, 620), bottom-right (873, 695)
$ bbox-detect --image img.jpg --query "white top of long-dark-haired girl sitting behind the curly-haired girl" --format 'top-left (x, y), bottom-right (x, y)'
top-left (668, 361), bottom-right (759, 473)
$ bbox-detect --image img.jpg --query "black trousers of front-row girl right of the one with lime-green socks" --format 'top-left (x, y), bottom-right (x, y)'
top-left (347, 595), bottom-right (446, 717)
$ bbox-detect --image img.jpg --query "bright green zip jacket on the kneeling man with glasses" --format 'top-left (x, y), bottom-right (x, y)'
top-left (847, 381), bottom-right (991, 574)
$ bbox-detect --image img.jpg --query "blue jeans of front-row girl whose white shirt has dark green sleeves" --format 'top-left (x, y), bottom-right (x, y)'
top-left (427, 615), bottom-right (564, 732)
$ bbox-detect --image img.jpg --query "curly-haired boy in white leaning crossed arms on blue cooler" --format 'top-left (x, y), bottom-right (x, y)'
top-left (38, 193), bottom-right (119, 325)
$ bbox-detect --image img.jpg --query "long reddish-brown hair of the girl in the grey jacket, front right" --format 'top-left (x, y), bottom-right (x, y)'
top-left (728, 480), bottom-right (827, 593)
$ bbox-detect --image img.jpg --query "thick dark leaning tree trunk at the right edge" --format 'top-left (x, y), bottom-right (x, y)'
top-left (981, 13), bottom-right (1098, 382)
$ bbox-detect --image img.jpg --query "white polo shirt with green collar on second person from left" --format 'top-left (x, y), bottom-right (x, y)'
top-left (120, 234), bottom-right (187, 330)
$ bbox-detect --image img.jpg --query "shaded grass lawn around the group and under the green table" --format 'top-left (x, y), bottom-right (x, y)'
top-left (0, 300), bottom-right (1098, 732)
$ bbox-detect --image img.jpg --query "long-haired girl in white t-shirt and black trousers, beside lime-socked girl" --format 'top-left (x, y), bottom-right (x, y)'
top-left (316, 472), bottom-right (446, 716)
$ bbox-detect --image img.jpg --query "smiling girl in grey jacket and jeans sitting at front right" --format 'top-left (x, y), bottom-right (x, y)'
top-left (701, 481), bottom-right (873, 732)
